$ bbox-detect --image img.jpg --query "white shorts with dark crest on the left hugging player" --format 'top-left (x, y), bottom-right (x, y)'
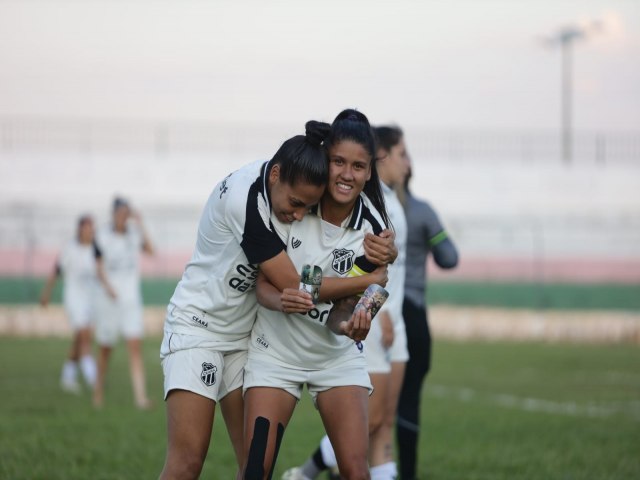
top-left (160, 332), bottom-right (247, 403)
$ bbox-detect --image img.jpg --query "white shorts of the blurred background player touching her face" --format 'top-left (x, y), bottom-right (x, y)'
top-left (95, 296), bottom-right (144, 347)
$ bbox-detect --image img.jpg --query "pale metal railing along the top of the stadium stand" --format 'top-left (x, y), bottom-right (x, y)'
top-left (0, 117), bottom-right (640, 165)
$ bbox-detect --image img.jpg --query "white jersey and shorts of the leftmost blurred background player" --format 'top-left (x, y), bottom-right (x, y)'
top-left (57, 240), bottom-right (100, 327)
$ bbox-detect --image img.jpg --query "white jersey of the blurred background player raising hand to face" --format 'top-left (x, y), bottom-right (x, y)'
top-left (96, 222), bottom-right (142, 304)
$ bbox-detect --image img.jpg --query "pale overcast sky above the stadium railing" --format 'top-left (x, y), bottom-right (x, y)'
top-left (0, 0), bottom-right (640, 131)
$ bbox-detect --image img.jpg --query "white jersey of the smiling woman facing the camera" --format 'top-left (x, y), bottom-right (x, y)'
top-left (249, 193), bottom-right (384, 370)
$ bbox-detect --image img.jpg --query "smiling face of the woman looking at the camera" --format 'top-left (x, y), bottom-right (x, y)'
top-left (327, 140), bottom-right (371, 211)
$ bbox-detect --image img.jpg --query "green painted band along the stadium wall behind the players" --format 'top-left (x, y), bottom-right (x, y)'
top-left (0, 277), bottom-right (640, 311)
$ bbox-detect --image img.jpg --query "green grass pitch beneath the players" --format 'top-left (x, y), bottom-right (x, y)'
top-left (0, 337), bottom-right (640, 480)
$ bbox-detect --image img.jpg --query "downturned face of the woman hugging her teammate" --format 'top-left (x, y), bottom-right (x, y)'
top-left (269, 165), bottom-right (325, 223)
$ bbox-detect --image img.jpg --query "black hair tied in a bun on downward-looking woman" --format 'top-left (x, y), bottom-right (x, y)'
top-left (268, 120), bottom-right (331, 186)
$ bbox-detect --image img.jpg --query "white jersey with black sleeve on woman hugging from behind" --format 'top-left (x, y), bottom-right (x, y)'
top-left (165, 162), bottom-right (285, 349)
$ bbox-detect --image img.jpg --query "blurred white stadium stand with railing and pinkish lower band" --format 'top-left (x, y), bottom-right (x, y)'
top-left (0, 120), bottom-right (640, 282)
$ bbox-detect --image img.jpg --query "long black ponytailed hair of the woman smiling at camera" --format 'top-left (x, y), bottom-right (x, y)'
top-left (324, 108), bottom-right (391, 228)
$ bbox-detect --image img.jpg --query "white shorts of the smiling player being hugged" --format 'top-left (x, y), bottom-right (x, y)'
top-left (244, 353), bottom-right (373, 405)
